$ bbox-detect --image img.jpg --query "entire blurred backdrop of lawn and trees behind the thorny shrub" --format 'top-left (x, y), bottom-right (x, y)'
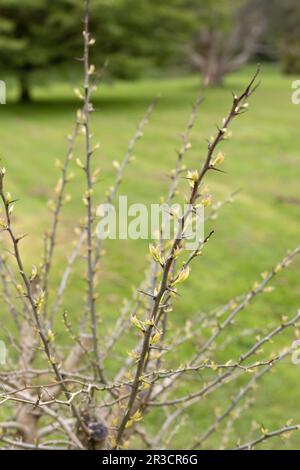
top-left (0, 0), bottom-right (300, 448)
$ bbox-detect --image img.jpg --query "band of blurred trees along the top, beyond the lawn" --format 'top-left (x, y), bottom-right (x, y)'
top-left (0, 0), bottom-right (300, 101)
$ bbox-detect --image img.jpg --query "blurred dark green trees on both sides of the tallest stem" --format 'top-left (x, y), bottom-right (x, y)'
top-left (0, 0), bottom-right (194, 101)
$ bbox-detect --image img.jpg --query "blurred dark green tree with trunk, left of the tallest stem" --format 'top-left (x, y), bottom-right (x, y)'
top-left (0, 0), bottom-right (81, 102)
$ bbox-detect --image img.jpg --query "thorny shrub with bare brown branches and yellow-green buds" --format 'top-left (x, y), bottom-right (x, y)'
top-left (0, 2), bottom-right (300, 450)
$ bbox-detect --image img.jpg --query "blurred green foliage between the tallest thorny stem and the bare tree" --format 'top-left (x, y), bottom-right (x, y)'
top-left (92, 0), bottom-right (197, 78)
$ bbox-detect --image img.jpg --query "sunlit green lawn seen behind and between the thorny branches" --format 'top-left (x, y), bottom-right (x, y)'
top-left (0, 67), bottom-right (300, 448)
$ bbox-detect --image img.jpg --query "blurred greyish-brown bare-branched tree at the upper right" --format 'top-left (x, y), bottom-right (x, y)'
top-left (187, 0), bottom-right (272, 86)
